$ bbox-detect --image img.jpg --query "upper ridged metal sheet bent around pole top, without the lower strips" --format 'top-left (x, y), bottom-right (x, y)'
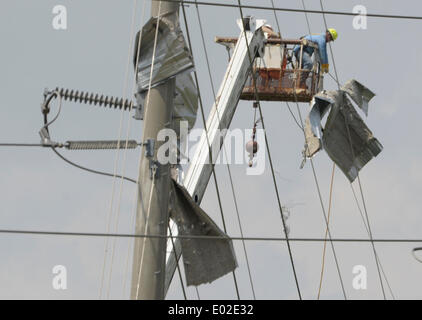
top-left (134, 13), bottom-right (194, 91)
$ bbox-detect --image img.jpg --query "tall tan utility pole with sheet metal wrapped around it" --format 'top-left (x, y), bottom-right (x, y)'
top-left (130, 1), bottom-right (179, 300)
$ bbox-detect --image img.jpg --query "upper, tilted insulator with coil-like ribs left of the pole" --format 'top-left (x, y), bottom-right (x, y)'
top-left (56, 88), bottom-right (133, 110)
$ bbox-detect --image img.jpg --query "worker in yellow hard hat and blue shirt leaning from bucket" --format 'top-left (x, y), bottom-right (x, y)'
top-left (290, 28), bottom-right (337, 89)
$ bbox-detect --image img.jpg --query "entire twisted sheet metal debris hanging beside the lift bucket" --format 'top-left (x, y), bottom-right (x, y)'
top-left (305, 80), bottom-right (383, 182)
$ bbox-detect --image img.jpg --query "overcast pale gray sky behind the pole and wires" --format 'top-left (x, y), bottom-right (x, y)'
top-left (0, 0), bottom-right (422, 299)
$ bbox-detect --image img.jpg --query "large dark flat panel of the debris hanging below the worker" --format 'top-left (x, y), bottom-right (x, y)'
top-left (323, 90), bottom-right (383, 182)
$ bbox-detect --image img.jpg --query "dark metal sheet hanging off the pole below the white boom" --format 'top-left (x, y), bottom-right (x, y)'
top-left (170, 180), bottom-right (237, 286)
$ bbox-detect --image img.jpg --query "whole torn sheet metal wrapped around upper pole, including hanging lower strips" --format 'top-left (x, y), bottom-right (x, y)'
top-left (133, 12), bottom-right (198, 130)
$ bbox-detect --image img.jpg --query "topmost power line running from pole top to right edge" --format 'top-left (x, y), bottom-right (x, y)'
top-left (156, 0), bottom-right (422, 20)
